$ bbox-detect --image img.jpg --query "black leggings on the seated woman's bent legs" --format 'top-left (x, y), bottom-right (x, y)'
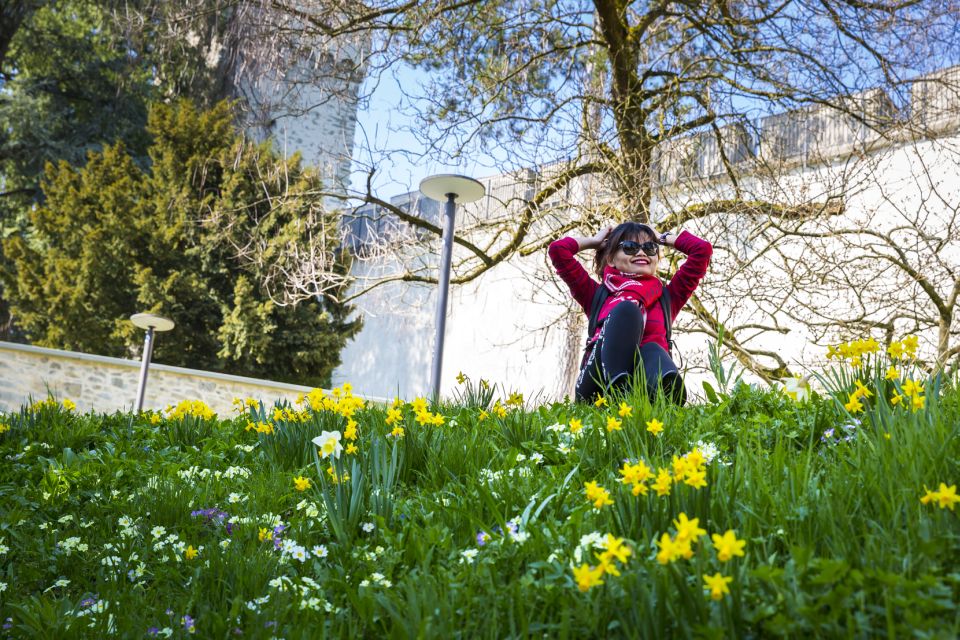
top-left (576, 301), bottom-right (686, 405)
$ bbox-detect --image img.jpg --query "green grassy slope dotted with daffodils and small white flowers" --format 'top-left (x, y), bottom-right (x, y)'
top-left (0, 363), bottom-right (960, 638)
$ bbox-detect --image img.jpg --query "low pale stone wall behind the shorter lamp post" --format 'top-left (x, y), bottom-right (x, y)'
top-left (0, 342), bottom-right (334, 416)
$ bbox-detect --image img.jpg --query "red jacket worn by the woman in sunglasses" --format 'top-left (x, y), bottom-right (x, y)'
top-left (548, 231), bottom-right (713, 349)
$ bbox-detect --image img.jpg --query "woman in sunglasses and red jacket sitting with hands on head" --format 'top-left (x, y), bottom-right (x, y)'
top-left (549, 222), bottom-right (713, 404)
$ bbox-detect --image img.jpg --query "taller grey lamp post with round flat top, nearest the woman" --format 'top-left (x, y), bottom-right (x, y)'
top-left (420, 173), bottom-right (486, 400)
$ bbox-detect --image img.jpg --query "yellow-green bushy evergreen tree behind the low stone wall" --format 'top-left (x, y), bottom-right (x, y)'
top-left (0, 102), bottom-right (360, 385)
